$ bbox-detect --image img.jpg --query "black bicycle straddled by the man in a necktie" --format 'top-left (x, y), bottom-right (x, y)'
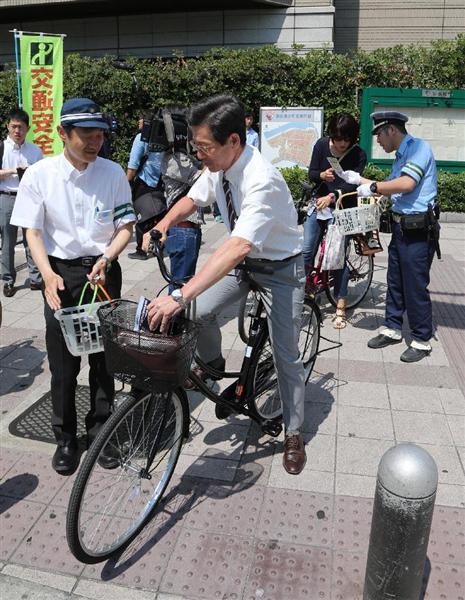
top-left (66, 231), bottom-right (320, 563)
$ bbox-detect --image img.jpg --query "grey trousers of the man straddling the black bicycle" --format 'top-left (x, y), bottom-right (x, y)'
top-left (197, 255), bottom-right (305, 431)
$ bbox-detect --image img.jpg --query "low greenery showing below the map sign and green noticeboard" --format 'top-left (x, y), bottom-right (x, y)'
top-left (281, 164), bottom-right (465, 212)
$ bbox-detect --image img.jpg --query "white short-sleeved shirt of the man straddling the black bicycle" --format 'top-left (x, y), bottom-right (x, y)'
top-left (187, 145), bottom-right (302, 260)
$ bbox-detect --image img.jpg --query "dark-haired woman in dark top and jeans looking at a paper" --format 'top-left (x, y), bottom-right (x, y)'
top-left (303, 112), bottom-right (367, 329)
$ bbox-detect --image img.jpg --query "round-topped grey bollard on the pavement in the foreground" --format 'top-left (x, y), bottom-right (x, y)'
top-left (363, 444), bottom-right (438, 600)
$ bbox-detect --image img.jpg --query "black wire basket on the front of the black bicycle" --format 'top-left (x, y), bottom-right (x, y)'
top-left (98, 300), bottom-right (199, 392)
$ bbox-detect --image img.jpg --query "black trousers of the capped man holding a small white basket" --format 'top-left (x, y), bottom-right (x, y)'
top-left (44, 256), bottom-right (122, 445)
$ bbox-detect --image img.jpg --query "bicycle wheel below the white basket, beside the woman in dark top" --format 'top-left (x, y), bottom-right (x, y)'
top-left (325, 238), bottom-right (374, 308)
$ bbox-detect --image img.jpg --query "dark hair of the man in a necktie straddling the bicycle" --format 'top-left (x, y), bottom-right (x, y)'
top-left (189, 94), bottom-right (246, 146)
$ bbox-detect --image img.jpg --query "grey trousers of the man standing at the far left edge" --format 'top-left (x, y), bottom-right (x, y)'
top-left (0, 193), bottom-right (42, 284)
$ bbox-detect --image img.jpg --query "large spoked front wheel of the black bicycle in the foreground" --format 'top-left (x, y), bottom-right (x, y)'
top-left (66, 389), bottom-right (188, 564)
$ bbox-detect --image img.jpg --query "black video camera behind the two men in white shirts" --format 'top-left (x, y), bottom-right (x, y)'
top-left (140, 108), bottom-right (190, 154)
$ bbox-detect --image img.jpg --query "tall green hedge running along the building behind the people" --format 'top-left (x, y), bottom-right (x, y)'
top-left (0, 34), bottom-right (465, 210)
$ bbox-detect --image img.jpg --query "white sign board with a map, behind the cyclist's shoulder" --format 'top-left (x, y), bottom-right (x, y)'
top-left (260, 106), bottom-right (323, 169)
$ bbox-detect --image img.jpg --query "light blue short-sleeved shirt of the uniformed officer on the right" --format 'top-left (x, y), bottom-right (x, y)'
top-left (388, 134), bottom-right (438, 215)
